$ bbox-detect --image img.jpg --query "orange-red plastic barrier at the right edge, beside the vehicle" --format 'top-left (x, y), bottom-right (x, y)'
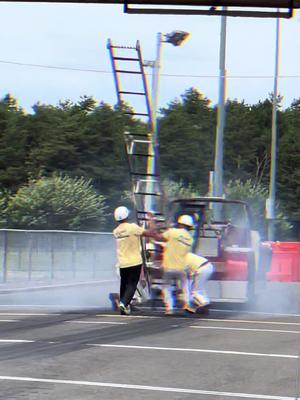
top-left (267, 242), bottom-right (300, 282)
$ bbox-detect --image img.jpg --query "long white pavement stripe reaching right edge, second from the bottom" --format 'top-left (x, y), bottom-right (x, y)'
top-left (91, 343), bottom-right (299, 359)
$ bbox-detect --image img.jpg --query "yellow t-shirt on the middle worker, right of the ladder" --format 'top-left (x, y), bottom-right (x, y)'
top-left (162, 228), bottom-right (193, 270)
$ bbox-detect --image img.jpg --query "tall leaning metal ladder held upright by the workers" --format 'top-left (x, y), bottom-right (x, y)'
top-left (107, 39), bottom-right (165, 299)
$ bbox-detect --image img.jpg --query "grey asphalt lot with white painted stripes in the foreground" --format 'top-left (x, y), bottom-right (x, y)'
top-left (0, 306), bottom-right (300, 400)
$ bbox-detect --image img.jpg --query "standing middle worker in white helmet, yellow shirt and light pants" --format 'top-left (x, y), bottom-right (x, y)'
top-left (155, 215), bottom-right (194, 315)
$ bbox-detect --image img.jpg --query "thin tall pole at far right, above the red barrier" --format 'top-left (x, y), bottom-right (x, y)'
top-left (267, 12), bottom-right (280, 241)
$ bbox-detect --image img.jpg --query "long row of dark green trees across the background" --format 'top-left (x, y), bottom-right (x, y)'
top-left (0, 89), bottom-right (300, 238)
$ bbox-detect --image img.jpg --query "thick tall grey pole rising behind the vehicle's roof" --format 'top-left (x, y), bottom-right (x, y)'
top-left (214, 7), bottom-right (227, 214)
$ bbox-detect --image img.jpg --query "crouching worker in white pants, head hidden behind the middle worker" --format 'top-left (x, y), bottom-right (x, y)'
top-left (185, 253), bottom-right (214, 313)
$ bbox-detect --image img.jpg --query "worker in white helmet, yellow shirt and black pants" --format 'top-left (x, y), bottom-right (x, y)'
top-left (113, 206), bottom-right (151, 315)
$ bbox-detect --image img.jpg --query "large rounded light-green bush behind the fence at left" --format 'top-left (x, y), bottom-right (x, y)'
top-left (4, 175), bottom-right (107, 230)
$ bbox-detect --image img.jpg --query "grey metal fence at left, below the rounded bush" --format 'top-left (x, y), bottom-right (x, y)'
top-left (0, 229), bottom-right (116, 283)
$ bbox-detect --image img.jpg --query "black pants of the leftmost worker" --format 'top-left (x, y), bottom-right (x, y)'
top-left (120, 264), bottom-right (142, 307)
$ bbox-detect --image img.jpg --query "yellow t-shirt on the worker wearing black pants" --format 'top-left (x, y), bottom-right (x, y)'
top-left (113, 222), bottom-right (144, 268)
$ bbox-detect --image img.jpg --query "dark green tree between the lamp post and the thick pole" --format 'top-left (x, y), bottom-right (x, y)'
top-left (159, 88), bottom-right (215, 193)
